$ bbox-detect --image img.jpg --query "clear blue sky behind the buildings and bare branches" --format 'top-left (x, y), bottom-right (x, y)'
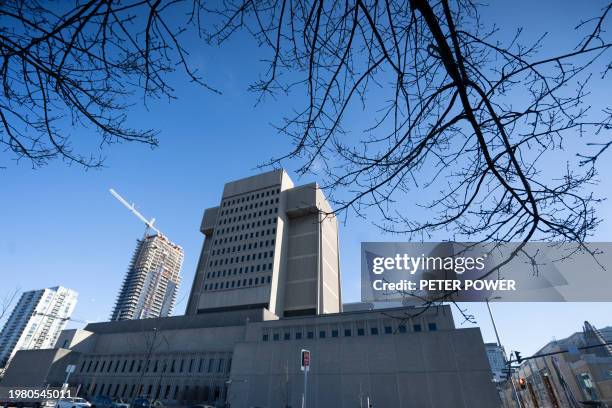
top-left (0, 1), bottom-right (612, 355)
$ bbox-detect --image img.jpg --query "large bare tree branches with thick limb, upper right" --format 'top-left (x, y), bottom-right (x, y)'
top-left (208, 0), bottom-right (612, 250)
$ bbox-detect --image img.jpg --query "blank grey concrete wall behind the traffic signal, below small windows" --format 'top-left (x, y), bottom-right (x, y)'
top-left (229, 329), bottom-right (499, 408)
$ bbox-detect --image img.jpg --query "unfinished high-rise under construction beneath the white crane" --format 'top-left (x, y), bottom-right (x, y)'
top-left (111, 233), bottom-right (184, 320)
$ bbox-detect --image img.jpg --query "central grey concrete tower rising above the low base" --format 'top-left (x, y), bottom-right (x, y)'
top-left (186, 170), bottom-right (342, 317)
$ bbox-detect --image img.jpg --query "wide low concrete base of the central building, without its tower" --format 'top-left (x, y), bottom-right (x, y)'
top-left (2, 306), bottom-right (499, 408)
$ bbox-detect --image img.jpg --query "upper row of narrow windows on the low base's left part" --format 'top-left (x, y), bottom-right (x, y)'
top-left (80, 357), bottom-right (232, 373)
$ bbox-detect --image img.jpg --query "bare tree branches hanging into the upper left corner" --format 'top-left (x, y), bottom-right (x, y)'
top-left (0, 0), bottom-right (215, 168)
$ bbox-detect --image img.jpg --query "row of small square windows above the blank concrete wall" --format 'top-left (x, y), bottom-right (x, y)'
top-left (262, 322), bottom-right (438, 341)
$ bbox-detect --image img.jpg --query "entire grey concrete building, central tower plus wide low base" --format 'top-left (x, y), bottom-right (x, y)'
top-left (2, 170), bottom-right (500, 408)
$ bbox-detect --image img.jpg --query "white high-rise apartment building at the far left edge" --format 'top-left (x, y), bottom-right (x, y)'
top-left (0, 286), bottom-right (77, 367)
